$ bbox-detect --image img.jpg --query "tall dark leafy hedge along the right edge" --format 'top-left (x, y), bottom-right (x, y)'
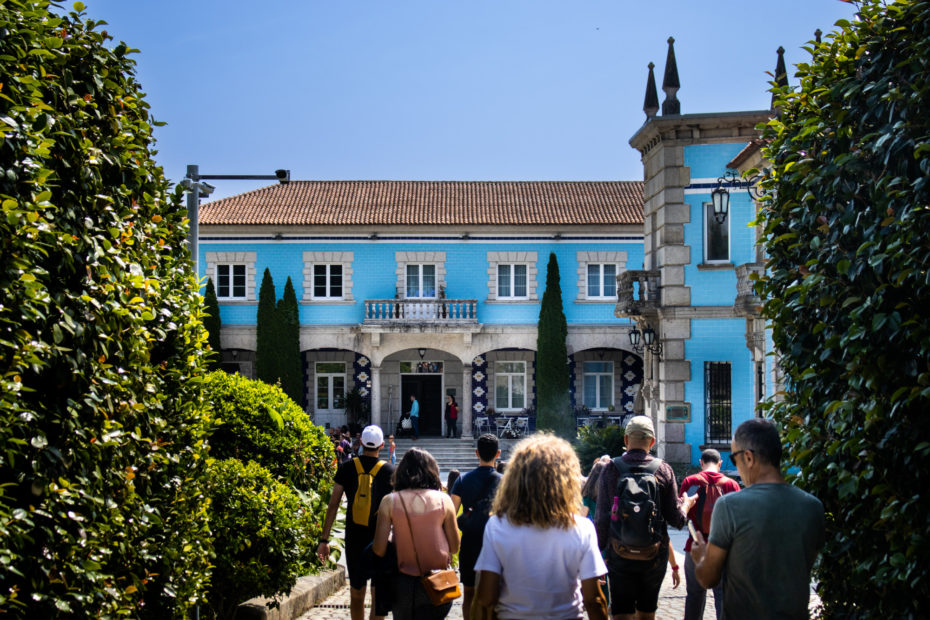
top-left (757, 0), bottom-right (930, 618)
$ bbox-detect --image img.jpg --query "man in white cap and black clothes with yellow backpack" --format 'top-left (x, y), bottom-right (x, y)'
top-left (317, 426), bottom-right (394, 620)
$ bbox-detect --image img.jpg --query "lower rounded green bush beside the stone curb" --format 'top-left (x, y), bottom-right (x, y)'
top-left (207, 459), bottom-right (321, 618)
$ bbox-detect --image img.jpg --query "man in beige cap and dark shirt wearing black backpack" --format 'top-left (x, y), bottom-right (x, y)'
top-left (594, 416), bottom-right (695, 620)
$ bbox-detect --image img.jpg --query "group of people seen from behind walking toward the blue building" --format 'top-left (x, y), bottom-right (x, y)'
top-left (318, 416), bottom-right (824, 620)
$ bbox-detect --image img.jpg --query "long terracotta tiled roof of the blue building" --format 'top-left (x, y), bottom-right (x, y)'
top-left (200, 181), bottom-right (643, 226)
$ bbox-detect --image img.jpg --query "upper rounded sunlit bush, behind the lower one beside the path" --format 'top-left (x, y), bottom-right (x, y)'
top-left (205, 372), bottom-right (335, 496)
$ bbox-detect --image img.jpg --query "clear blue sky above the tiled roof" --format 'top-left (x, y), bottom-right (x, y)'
top-left (85, 0), bottom-right (855, 197)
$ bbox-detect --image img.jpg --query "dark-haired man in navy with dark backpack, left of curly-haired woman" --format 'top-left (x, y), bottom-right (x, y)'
top-left (451, 433), bottom-right (503, 618)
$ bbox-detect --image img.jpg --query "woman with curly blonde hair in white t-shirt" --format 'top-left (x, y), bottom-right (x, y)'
top-left (475, 434), bottom-right (608, 620)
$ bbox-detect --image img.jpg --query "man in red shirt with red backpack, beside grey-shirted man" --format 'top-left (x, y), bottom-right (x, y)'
top-left (681, 448), bottom-right (739, 620)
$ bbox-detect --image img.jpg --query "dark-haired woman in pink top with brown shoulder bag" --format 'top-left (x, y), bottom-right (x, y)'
top-left (373, 448), bottom-right (459, 620)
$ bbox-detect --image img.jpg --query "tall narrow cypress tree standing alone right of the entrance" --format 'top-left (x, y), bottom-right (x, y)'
top-left (536, 253), bottom-right (575, 440)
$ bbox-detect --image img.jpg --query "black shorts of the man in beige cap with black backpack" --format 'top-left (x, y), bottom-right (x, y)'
top-left (607, 544), bottom-right (668, 615)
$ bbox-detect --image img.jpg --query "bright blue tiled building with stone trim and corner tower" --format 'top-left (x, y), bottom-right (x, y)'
top-left (198, 39), bottom-right (784, 462)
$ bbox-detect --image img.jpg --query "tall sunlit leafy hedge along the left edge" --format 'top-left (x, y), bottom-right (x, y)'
top-left (0, 0), bottom-right (209, 618)
